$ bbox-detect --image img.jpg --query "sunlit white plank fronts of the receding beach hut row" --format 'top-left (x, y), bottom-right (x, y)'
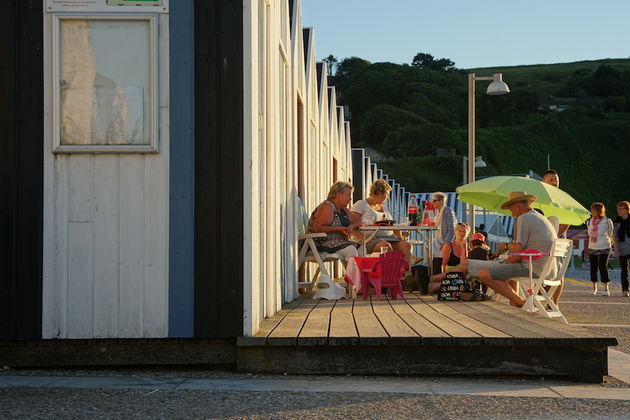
top-left (243, 0), bottom-right (352, 335)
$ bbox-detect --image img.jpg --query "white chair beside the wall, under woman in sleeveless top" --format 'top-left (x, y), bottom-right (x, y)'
top-left (297, 198), bottom-right (344, 290)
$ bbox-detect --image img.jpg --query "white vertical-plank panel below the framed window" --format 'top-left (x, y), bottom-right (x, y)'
top-left (43, 154), bottom-right (168, 338)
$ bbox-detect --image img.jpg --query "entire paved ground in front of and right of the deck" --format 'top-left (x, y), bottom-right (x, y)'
top-left (0, 270), bottom-right (630, 419)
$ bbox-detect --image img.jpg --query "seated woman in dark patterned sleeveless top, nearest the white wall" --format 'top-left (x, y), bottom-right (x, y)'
top-left (308, 181), bottom-right (360, 259)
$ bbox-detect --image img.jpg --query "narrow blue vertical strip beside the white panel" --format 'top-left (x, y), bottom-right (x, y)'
top-left (169, 0), bottom-right (195, 337)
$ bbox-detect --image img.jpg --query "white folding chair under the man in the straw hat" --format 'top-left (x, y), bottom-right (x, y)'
top-left (515, 238), bottom-right (573, 324)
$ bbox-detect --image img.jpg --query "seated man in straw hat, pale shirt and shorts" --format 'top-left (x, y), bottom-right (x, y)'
top-left (452, 191), bottom-right (556, 307)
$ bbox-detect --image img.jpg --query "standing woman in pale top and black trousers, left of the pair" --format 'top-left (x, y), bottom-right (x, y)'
top-left (586, 203), bottom-right (614, 296)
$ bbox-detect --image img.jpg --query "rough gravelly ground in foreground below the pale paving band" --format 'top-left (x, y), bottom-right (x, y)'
top-left (0, 388), bottom-right (630, 419)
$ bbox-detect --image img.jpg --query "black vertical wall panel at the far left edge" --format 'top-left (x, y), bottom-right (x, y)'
top-left (0, 1), bottom-right (44, 340)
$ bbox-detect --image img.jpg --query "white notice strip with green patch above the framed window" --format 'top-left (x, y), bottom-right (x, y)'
top-left (46, 0), bottom-right (168, 13)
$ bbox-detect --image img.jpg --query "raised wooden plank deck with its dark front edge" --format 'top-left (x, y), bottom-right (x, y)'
top-left (237, 293), bottom-right (617, 382)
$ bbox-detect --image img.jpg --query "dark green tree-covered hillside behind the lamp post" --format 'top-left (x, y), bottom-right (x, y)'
top-left (333, 54), bottom-right (630, 213)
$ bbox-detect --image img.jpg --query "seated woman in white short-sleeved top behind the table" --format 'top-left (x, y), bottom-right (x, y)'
top-left (352, 179), bottom-right (412, 263)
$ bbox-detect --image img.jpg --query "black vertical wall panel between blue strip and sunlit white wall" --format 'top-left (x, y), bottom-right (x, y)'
top-left (195, 0), bottom-right (246, 337)
